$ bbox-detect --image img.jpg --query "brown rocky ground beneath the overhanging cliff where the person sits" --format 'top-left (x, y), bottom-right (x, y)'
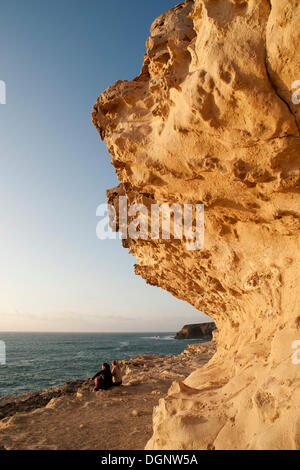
top-left (0, 343), bottom-right (215, 450)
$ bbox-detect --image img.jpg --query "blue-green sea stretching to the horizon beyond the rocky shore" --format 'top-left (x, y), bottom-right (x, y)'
top-left (0, 333), bottom-right (204, 397)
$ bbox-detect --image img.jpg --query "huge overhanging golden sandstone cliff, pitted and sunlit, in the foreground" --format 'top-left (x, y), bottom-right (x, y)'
top-left (93, 0), bottom-right (300, 450)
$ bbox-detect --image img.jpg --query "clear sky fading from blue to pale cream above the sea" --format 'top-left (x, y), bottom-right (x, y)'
top-left (0, 0), bottom-right (211, 331)
